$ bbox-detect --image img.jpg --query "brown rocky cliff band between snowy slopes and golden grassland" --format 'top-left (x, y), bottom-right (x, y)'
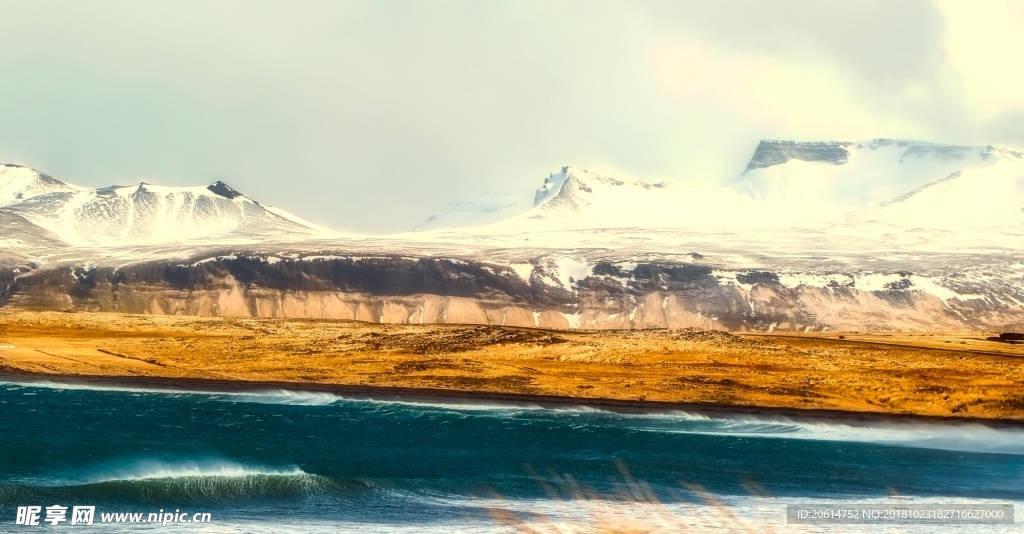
top-left (0, 255), bottom-right (1024, 331)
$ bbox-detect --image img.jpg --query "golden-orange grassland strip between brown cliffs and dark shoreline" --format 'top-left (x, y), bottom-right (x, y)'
top-left (0, 310), bottom-right (1024, 420)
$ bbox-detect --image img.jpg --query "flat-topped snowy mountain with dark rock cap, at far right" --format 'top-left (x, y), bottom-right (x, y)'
top-left (731, 139), bottom-right (1024, 224)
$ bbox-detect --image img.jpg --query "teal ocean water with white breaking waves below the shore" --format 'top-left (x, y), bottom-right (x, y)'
top-left (0, 382), bottom-right (1024, 533)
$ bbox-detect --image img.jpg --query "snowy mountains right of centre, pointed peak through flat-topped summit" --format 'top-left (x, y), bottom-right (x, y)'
top-left (421, 138), bottom-right (1024, 235)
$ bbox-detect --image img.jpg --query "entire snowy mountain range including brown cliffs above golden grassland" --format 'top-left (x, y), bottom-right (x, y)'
top-left (6, 139), bottom-right (1024, 331)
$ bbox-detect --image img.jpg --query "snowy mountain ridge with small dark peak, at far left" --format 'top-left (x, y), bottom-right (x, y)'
top-left (0, 166), bottom-right (327, 248)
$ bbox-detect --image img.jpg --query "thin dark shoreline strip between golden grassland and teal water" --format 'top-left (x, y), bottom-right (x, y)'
top-left (0, 367), bottom-right (1024, 428)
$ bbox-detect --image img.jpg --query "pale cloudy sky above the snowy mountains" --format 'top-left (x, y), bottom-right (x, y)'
top-left (0, 0), bottom-right (1024, 233)
